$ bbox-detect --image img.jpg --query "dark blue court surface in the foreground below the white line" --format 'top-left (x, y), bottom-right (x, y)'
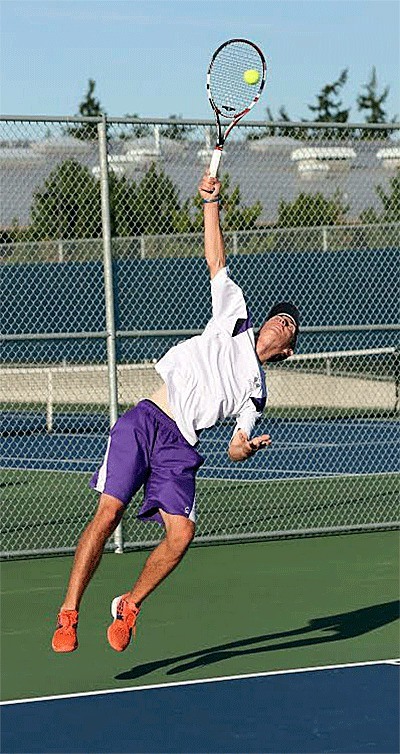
top-left (1, 660), bottom-right (400, 754)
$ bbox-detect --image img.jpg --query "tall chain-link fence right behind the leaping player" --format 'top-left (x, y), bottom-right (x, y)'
top-left (0, 117), bottom-right (400, 557)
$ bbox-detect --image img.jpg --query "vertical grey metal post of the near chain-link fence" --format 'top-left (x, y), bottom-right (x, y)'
top-left (97, 115), bottom-right (123, 553)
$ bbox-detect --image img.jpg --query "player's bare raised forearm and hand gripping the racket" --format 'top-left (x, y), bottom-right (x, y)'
top-left (199, 171), bottom-right (226, 280)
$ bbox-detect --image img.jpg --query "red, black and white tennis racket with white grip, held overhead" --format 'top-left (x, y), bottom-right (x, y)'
top-left (207, 39), bottom-right (267, 178)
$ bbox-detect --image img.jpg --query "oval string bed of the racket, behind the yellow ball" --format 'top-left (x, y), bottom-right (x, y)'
top-left (210, 42), bottom-right (264, 119)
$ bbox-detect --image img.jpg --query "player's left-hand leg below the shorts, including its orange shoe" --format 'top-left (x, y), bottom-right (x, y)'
top-left (52, 493), bottom-right (125, 652)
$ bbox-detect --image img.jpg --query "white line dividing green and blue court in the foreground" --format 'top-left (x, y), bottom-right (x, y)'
top-left (0, 658), bottom-right (400, 707)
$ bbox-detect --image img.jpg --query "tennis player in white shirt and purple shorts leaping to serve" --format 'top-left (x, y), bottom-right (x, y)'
top-left (52, 171), bottom-right (299, 652)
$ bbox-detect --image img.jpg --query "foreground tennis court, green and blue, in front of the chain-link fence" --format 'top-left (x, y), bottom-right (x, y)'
top-left (1, 532), bottom-right (399, 754)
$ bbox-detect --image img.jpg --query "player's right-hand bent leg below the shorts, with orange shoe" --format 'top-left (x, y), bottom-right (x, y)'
top-left (107, 509), bottom-right (195, 652)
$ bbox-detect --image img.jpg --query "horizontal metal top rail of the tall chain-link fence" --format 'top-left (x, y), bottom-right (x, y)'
top-left (0, 115), bottom-right (400, 131)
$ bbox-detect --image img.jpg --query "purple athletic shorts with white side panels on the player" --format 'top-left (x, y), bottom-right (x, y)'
top-left (89, 400), bottom-right (204, 524)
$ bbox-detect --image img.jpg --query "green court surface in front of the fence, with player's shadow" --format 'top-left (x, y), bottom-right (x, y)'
top-left (1, 532), bottom-right (399, 700)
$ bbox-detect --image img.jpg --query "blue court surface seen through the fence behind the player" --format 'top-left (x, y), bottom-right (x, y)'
top-left (2, 415), bottom-right (400, 481)
